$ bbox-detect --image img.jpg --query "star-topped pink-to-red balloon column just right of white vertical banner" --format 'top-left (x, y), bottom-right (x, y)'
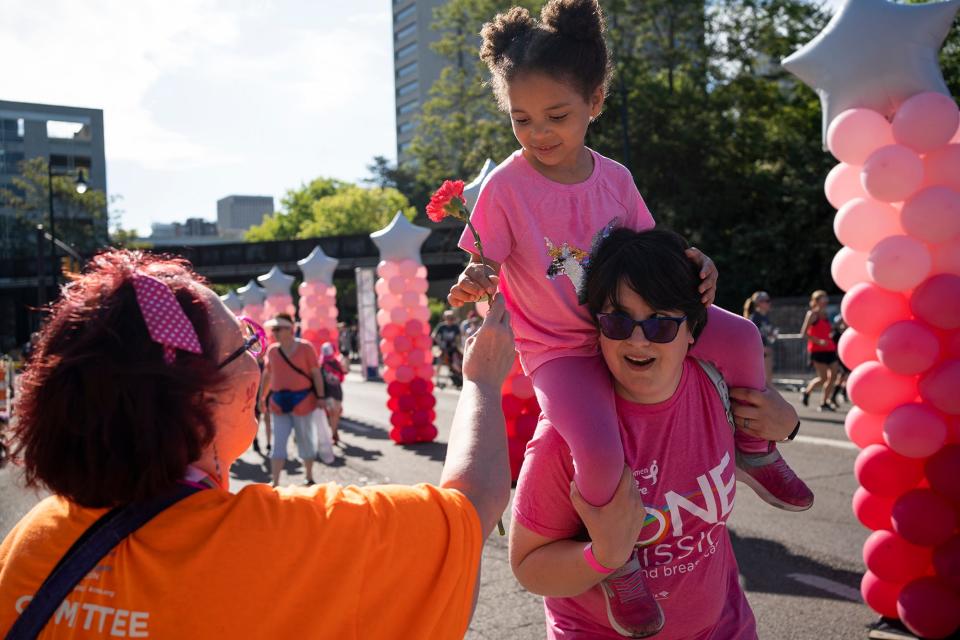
top-left (370, 213), bottom-right (437, 444)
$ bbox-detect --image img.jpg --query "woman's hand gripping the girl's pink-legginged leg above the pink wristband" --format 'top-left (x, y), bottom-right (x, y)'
top-left (570, 467), bottom-right (647, 569)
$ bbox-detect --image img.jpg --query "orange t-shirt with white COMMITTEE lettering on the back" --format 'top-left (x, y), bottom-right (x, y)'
top-left (0, 484), bottom-right (483, 640)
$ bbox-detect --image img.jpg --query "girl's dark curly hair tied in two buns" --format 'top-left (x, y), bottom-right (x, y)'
top-left (480, 0), bottom-right (613, 110)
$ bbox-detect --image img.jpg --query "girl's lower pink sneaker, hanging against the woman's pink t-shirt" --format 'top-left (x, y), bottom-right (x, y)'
top-left (600, 549), bottom-right (664, 638)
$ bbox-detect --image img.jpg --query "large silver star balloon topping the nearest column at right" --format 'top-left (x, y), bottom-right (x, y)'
top-left (782, 0), bottom-right (960, 148)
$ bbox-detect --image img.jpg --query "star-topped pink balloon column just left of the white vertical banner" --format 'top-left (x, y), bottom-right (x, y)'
top-left (297, 246), bottom-right (340, 353)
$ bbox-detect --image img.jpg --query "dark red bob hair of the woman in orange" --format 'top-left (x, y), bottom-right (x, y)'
top-left (14, 250), bottom-right (224, 507)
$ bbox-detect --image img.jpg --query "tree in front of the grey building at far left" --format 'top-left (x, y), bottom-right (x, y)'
top-left (0, 158), bottom-right (107, 256)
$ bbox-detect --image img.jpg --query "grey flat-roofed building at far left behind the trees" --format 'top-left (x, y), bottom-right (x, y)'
top-left (0, 100), bottom-right (107, 257)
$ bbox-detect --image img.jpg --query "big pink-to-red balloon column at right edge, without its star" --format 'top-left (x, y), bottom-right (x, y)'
top-left (826, 93), bottom-right (960, 638)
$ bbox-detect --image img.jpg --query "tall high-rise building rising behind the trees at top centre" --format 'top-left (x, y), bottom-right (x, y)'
top-left (393, 0), bottom-right (446, 165)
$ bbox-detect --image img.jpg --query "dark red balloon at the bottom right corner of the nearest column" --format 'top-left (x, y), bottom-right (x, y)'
top-left (897, 577), bottom-right (960, 639)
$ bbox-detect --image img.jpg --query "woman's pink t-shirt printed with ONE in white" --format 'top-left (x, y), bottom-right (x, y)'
top-left (513, 358), bottom-right (757, 640)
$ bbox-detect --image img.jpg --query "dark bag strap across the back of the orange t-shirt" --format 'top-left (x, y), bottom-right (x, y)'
top-left (6, 484), bottom-right (202, 640)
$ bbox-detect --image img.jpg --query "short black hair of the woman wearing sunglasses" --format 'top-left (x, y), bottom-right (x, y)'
top-left (584, 229), bottom-right (707, 338)
